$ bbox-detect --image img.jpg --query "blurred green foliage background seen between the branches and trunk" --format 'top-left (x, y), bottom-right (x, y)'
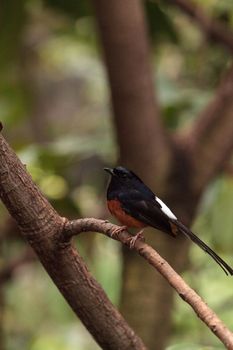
top-left (0, 0), bottom-right (233, 350)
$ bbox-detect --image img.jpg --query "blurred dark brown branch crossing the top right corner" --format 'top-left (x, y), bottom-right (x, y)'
top-left (162, 0), bottom-right (233, 53)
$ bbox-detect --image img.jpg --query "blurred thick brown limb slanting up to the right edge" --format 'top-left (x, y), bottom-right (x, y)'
top-left (183, 65), bottom-right (233, 193)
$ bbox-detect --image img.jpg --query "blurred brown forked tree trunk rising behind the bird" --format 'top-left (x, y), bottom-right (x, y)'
top-left (93, 0), bottom-right (233, 350)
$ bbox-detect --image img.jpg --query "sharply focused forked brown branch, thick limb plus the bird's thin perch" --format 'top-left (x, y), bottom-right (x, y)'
top-left (0, 135), bottom-right (233, 350)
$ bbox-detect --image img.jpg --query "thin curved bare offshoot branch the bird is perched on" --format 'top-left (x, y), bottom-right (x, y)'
top-left (61, 218), bottom-right (233, 349)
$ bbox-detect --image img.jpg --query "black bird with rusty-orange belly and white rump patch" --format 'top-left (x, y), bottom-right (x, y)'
top-left (104, 166), bottom-right (233, 275)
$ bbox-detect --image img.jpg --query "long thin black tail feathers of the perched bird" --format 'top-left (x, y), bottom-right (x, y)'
top-left (174, 220), bottom-right (233, 275)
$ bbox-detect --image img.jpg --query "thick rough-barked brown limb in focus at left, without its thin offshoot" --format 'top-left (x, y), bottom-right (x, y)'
top-left (0, 135), bottom-right (145, 350)
